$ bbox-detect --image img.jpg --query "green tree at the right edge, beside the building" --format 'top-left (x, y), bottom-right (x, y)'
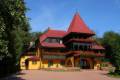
top-left (102, 31), bottom-right (120, 72)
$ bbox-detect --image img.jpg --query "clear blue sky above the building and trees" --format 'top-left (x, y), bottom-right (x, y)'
top-left (25, 0), bottom-right (120, 37)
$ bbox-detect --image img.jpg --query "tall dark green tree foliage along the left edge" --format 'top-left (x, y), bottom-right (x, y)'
top-left (0, 0), bottom-right (30, 77)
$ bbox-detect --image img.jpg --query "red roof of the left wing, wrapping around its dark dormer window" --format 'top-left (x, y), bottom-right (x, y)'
top-left (39, 29), bottom-right (66, 48)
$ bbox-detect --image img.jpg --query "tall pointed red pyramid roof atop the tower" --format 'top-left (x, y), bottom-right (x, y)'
top-left (68, 13), bottom-right (95, 34)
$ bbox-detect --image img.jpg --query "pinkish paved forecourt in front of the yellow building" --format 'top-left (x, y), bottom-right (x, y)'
top-left (2, 70), bottom-right (120, 80)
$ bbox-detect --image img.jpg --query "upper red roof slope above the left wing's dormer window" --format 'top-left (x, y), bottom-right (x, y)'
top-left (40, 29), bottom-right (66, 42)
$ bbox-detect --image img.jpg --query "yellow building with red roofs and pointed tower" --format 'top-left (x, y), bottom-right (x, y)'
top-left (20, 13), bottom-right (104, 69)
